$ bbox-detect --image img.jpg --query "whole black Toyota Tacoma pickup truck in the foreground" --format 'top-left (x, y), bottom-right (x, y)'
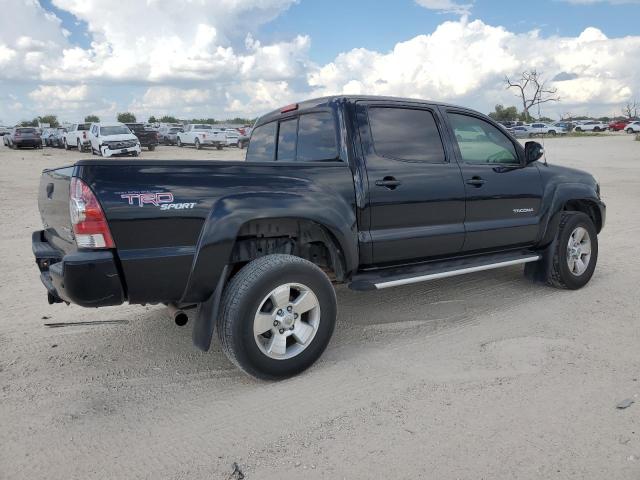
top-left (32, 96), bottom-right (605, 378)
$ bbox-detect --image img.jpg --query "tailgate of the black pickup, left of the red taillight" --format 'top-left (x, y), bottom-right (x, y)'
top-left (38, 167), bottom-right (77, 254)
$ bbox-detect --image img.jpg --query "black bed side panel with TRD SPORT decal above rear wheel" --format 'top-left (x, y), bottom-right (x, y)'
top-left (77, 160), bottom-right (357, 303)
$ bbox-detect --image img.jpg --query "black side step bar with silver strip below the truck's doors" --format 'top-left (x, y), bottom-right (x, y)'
top-left (349, 251), bottom-right (541, 291)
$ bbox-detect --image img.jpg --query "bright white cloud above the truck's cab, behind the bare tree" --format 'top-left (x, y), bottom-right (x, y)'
top-left (309, 18), bottom-right (640, 118)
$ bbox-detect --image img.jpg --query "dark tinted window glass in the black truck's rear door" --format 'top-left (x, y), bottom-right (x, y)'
top-left (369, 107), bottom-right (446, 163)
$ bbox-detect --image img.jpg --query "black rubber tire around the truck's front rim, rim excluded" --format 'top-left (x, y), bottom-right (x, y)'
top-left (547, 212), bottom-right (598, 290)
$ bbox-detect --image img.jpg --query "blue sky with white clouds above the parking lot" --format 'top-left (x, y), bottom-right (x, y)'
top-left (0, 0), bottom-right (640, 125)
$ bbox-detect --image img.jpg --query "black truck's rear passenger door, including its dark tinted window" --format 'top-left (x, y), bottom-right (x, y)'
top-left (357, 102), bottom-right (465, 264)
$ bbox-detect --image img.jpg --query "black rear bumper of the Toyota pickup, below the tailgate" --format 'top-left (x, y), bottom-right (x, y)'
top-left (31, 230), bottom-right (125, 307)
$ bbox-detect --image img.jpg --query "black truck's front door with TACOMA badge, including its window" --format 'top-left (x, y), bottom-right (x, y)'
top-left (448, 111), bottom-right (542, 252)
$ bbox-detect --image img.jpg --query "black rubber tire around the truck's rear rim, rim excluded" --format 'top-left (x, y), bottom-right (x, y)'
top-left (216, 254), bottom-right (337, 380)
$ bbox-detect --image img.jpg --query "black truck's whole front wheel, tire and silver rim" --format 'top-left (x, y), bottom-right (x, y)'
top-left (547, 212), bottom-right (598, 290)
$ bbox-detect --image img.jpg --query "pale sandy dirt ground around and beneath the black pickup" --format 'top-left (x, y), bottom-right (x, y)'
top-left (0, 134), bottom-right (640, 480)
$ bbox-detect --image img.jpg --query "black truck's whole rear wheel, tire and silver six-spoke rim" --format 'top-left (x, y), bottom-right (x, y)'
top-left (217, 254), bottom-right (337, 379)
